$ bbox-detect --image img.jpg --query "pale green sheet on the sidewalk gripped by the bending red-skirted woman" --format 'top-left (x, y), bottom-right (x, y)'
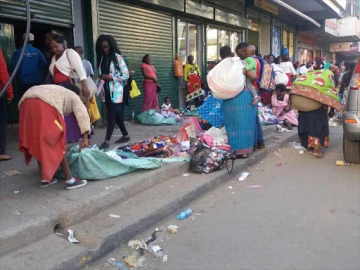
top-left (56, 149), bottom-right (162, 180)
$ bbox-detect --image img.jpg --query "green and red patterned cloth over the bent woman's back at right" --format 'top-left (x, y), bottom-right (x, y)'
top-left (290, 69), bottom-right (343, 112)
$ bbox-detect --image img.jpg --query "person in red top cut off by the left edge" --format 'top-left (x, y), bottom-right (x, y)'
top-left (0, 48), bottom-right (14, 161)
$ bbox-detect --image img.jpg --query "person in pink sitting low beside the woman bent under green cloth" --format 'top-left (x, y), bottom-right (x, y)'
top-left (271, 84), bottom-right (299, 130)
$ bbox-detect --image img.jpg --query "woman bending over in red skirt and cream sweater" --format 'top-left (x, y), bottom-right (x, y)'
top-left (19, 85), bottom-right (91, 189)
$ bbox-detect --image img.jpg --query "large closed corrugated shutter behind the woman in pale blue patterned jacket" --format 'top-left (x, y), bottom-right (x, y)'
top-left (99, 0), bottom-right (174, 116)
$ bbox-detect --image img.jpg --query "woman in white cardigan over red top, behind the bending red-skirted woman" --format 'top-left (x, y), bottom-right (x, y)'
top-left (49, 34), bottom-right (90, 143)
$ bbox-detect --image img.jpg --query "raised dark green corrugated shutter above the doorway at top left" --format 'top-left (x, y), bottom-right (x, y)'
top-left (0, 0), bottom-right (73, 27)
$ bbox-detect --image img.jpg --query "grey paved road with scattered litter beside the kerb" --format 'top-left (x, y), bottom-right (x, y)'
top-left (88, 127), bottom-right (360, 270)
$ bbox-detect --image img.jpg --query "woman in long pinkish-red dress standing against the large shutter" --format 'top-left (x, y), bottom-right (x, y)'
top-left (141, 54), bottom-right (159, 112)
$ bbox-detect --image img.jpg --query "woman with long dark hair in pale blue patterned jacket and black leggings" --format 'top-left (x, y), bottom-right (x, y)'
top-left (96, 35), bottom-right (130, 149)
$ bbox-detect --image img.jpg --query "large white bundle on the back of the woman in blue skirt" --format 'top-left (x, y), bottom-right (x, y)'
top-left (207, 57), bottom-right (245, 99)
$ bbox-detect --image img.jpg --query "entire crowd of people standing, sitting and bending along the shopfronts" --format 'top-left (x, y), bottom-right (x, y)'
top-left (0, 32), bottom-right (355, 189)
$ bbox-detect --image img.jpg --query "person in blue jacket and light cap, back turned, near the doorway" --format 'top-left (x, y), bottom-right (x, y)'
top-left (11, 33), bottom-right (46, 99)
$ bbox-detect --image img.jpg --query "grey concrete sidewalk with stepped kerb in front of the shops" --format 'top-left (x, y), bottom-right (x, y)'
top-left (0, 124), bottom-right (297, 270)
